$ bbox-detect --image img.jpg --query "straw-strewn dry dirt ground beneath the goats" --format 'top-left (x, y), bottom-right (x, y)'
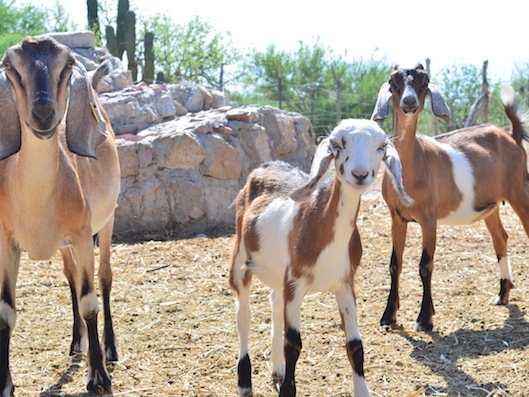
top-left (11, 177), bottom-right (529, 397)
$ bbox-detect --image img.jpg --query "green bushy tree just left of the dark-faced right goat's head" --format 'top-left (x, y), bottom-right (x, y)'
top-left (243, 39), bottom-right (390, 135)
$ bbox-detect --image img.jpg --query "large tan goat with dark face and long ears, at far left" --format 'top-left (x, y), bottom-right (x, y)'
top-left (0, 38), bottom-right (120, 397)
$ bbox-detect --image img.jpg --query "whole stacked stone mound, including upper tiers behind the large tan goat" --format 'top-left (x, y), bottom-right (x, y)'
top-left (42, 31), bottom-right (315, 236)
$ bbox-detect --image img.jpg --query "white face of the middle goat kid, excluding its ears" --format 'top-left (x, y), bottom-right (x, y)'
top-left (329, 120), bottom-right (387, 192)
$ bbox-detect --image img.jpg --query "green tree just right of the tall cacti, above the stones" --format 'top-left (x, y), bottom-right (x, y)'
top-left (140, 14), bottom-right (240, 89)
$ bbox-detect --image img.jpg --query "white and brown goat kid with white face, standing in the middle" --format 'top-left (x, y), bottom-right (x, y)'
top-left (229, 119), bottom-right (413, 397)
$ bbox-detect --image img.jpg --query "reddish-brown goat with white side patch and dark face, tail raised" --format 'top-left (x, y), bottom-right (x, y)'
top-left (372, 64), bottom-right (529, 331)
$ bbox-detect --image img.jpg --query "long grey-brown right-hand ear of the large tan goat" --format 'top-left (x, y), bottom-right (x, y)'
top-left (66, 62), bottom-right (106, 158)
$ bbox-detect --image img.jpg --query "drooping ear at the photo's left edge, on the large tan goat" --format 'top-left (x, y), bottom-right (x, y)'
top-left (0, 68), bottom-right (22, 160)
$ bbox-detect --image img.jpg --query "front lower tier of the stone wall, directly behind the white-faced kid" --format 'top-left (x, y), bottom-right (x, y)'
top-left (115, 106), bottom-right (315, 235)
